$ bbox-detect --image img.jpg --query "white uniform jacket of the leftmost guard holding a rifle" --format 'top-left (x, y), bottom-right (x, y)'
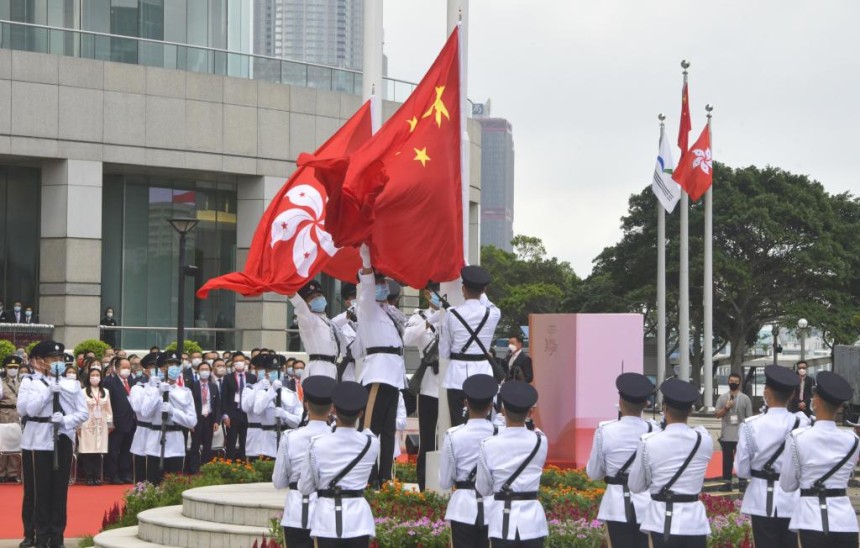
top-left (17, 373), bottom-right (89, 451)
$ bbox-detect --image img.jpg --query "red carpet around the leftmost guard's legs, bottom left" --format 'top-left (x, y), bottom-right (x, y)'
top-left (0, 483), bottom-right (131, 539)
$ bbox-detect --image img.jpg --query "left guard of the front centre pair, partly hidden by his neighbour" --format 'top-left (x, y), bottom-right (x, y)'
top-left (439, 375), bottom-right (499, 548)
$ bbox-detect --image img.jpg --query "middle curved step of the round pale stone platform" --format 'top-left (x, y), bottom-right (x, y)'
top-left (137, 505), bottom-right (269, 548)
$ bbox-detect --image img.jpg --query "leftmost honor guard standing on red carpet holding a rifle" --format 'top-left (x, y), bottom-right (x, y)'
top-left (17, 340), bottom-right (89, 547)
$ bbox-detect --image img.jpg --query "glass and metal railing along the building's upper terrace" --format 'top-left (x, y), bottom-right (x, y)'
top-left (0, 20), bottom-right (416, 102)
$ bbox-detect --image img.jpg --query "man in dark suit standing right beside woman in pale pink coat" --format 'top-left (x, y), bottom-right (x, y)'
top-left (104, 358), bottom-right (139, 484)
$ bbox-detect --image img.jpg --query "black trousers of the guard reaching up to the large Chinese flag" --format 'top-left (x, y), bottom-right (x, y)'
top-left (359, 382), bottom-right (400, 485)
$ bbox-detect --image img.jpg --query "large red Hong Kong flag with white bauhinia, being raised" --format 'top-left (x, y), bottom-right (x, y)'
top-left (197, 101), bottom-right (371, 299)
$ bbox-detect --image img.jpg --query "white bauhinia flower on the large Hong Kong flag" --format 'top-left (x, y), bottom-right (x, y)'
top-left (272, 185), bottom-right (338, 277)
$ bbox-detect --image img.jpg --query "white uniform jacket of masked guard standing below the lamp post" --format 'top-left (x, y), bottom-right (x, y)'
top-left (142, 384), bottom-right (197, 458)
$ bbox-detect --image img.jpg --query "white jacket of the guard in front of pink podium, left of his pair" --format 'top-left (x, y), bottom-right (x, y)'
top-left (585, 417), bottom-right (658, 523)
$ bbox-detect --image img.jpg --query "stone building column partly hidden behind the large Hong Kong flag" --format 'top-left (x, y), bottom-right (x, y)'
top-left (236, 177), bottom-right (287, 351)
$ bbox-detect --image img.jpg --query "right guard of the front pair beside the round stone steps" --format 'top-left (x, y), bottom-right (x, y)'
top-left (299, 381), bottom-right (379, 548)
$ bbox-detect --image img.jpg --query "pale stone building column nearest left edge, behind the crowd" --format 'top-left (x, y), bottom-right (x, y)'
top-left (38, 160), bottom-right (102, 348)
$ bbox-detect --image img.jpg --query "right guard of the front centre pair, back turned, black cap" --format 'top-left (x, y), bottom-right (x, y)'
top-left (475, 381), bottom-right (549, 548)
